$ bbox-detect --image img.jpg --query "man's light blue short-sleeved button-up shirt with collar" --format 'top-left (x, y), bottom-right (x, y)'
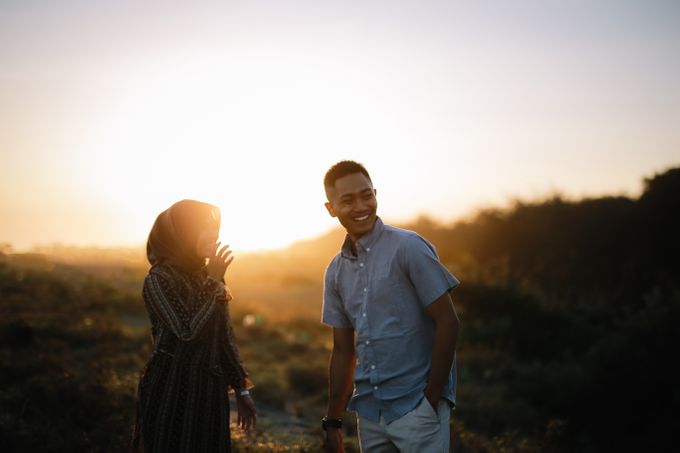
top-left (322, 218), bottom-right (459, 423)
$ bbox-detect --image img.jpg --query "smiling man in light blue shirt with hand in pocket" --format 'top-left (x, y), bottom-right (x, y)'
top-left (322, 161), bottom-right (459, 453)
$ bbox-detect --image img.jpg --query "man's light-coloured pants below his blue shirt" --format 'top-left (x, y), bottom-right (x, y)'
top-left (358, 398), bottom-right (451, 453)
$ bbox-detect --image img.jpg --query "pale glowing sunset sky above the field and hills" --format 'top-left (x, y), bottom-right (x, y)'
top-left (0, 0), bottom-right (680, 250)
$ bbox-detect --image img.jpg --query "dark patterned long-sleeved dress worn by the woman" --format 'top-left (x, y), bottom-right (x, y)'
top-left (132, 264), bottom-right (249, 453)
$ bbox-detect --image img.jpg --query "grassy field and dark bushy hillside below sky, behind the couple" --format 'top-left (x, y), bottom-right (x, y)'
top-left (0, 169), bottom-right (680, 452)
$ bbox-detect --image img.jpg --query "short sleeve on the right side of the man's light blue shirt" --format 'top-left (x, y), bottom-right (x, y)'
top-left (400, 234), bottom-right (460, 307)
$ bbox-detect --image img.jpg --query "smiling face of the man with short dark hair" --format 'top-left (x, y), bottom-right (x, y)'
top-left (326, 173), bottom-right (378, 242)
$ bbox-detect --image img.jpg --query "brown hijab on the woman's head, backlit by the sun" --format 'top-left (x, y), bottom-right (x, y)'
top-left (146, 200), bottom-right (220, 275)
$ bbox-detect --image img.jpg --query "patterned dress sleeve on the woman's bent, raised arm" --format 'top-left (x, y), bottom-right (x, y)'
top-left (143, 272), bottom-right (224, 341)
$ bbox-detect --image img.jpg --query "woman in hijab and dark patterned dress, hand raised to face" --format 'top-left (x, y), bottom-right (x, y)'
top-left (132, 200), bottom-right (256, 453)
